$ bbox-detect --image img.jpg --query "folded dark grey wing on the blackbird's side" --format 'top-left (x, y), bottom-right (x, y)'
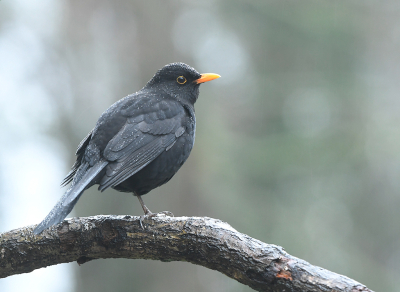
top-left (99, 101), bottom-right (185, 191)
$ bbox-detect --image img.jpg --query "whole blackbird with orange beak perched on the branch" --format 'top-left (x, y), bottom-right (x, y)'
top-left (33, 63), bottom-right (220, 234)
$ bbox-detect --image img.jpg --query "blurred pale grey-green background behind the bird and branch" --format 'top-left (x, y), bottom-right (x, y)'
top-left (0, 0), bottom-right (400, 292)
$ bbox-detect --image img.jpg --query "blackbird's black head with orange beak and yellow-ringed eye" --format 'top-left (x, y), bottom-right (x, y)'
top-left (144, 63), bottom-right (221, 104)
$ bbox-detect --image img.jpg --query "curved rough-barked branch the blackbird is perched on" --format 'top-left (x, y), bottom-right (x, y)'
top-left (0, 216), bottom-right (371, 292)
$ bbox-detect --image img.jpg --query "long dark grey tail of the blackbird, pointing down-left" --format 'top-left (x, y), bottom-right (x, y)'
top-left (33, 160), bottom-right (108, 234)
